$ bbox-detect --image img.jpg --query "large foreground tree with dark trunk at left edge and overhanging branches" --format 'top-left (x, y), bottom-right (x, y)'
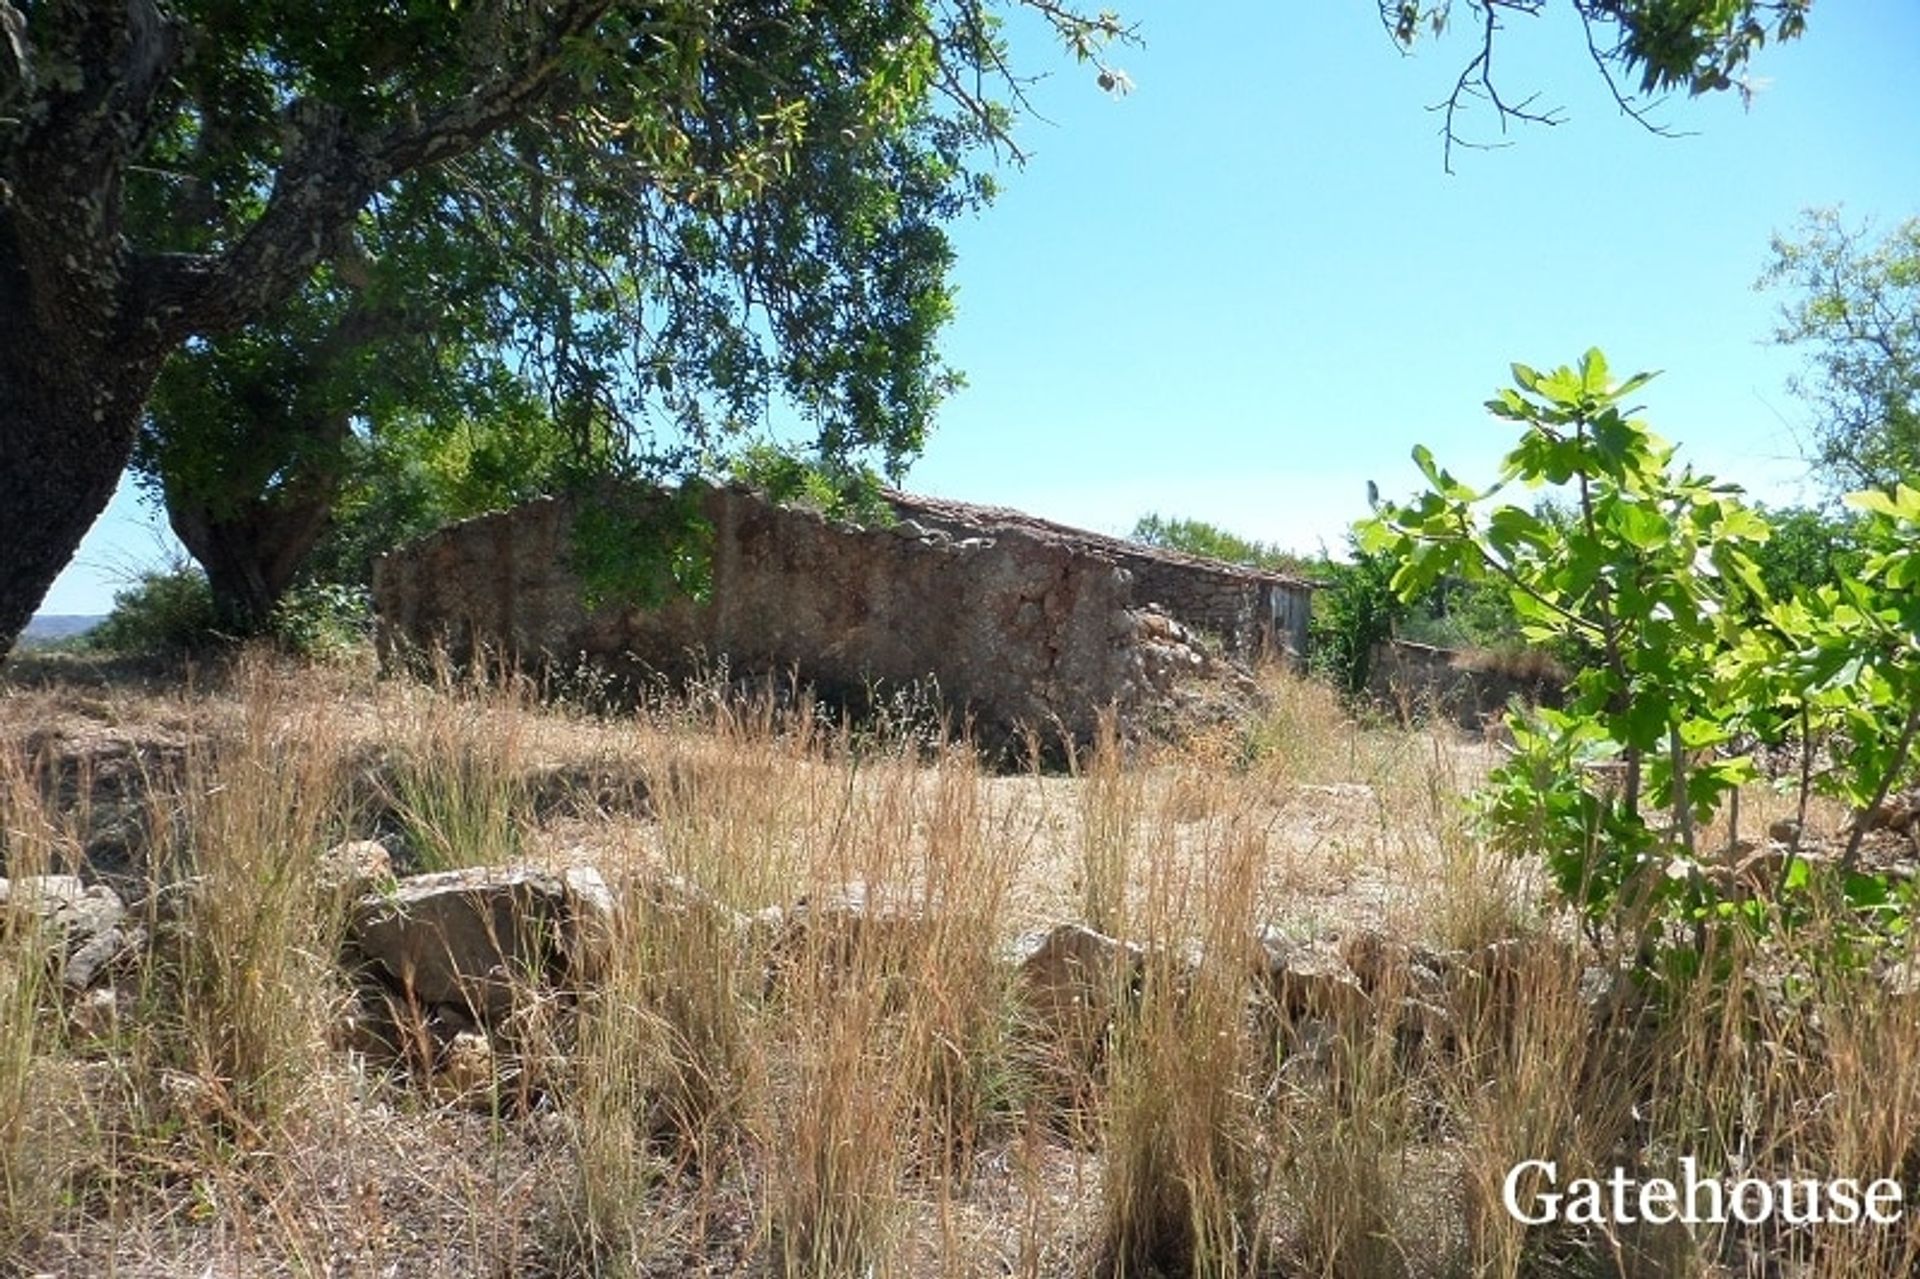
top-left (0, 0), bottom-right (1803, 647)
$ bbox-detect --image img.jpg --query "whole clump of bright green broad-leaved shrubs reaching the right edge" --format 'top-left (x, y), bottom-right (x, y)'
top-left (1357, 350), bottom-right (1920, 972)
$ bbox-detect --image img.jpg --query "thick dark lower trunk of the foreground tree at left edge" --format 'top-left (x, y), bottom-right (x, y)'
top-left (0, 209), bottom-right (159, 661)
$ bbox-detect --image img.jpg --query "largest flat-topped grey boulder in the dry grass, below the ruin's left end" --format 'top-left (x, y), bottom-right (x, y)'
top-left (348, 866), bottom-right (612, 1024)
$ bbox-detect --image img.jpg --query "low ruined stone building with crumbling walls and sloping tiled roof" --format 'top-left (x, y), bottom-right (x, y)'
top-left (374, 488), bottom-right (1311, 745)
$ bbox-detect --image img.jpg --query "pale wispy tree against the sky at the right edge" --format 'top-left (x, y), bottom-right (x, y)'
top-left (1761, 209), bottom-right (1920, 492)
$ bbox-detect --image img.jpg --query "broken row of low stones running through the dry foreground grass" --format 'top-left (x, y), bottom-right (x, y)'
top-left (0, 841), bottom-right (1681, 1098)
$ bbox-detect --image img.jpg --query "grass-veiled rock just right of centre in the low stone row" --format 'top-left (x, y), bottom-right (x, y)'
top-left (1006, 924), bottom-right (1146, 1068)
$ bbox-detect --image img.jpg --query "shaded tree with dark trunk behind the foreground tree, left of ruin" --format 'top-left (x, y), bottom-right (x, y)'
top-left (132, 161), bottom-right (614, 634)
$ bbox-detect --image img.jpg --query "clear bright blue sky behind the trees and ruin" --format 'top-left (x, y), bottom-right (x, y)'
top-left (33, 0), bottom-right (1920, 613)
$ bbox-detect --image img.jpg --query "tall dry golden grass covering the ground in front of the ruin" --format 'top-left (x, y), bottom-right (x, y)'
top-left (0, 661), bottom-right (1920, 1279)
